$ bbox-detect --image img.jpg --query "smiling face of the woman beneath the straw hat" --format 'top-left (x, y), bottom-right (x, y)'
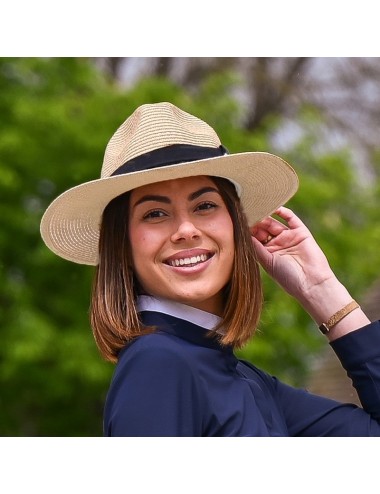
top-left (129, 176), bottom-right (234, 315)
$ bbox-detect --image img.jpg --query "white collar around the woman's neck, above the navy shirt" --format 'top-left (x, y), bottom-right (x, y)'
top-left (137, 295), bottom-right (222, 329)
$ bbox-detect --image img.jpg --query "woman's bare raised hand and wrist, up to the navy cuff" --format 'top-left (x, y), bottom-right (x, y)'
top-left (251, 207), bottom-right (370, 341)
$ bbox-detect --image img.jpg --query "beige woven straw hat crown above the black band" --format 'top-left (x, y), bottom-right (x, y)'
top-left (101, 102), bottom-right (221, 178)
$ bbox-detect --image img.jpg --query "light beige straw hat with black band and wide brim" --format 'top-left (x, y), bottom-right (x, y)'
top-left (41, 103), bottom-right (298, 265)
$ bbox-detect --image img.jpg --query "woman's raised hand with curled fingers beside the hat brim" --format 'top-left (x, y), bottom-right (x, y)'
top-left (251, 207), bottom-right (335, 302)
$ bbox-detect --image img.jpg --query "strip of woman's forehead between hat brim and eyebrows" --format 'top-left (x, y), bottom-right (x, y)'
top-left (132, 175), bottom-right (216, 199)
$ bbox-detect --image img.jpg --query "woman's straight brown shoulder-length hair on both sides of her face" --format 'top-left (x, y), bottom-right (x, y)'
top-left (90, 177), bottom-right (263, 362)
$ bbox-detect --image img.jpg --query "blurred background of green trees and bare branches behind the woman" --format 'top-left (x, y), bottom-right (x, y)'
top-left (0, 57), bottom-right (380, 436)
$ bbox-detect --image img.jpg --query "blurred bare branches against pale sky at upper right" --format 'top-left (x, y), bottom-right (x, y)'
top-left (95, 57), bottom-right (380, 180)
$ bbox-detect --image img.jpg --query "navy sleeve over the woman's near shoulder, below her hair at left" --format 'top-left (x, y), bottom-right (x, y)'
top-left (104, 337), bottom-right (203, 437)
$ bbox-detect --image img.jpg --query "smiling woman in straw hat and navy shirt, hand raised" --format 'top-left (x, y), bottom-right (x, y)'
top-left (41, 103), bottom-right (380, 436)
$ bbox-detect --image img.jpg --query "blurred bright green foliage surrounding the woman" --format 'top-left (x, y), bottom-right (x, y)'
top-left (0, 58), bottom-right (380, 436)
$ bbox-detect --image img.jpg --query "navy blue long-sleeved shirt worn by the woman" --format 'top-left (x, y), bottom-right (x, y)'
top-left (104, 311), bottom-right (380, 437)
